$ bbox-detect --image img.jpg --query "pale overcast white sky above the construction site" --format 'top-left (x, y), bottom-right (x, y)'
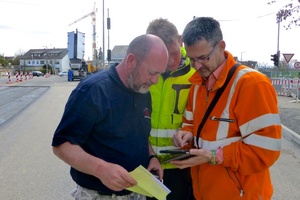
top-left (0, 0), bottom-right (300, 66)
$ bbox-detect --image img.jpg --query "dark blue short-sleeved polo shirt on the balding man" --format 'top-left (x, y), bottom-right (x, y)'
top-left (52, 67), bottom-right (151, 195)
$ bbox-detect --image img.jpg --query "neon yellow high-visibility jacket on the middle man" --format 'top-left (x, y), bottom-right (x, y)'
top-left (149, 48), bottom-right (195, 169)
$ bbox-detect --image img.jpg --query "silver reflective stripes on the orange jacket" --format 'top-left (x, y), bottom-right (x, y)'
top-left (192, 68), bottom-right (281, 150)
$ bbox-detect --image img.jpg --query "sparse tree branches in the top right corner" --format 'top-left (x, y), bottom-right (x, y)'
top-left (268, 0), bottom-right (300, 29)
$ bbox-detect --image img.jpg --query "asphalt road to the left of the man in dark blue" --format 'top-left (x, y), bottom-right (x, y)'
top-left (0, 77), bottom-right (78, 200)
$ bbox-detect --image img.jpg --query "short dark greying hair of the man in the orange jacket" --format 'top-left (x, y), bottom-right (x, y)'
top-left (182, 17), bottom-right (223, 46)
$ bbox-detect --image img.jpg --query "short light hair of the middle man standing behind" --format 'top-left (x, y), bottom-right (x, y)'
top-left (146, 18), bottom-right (179, 46)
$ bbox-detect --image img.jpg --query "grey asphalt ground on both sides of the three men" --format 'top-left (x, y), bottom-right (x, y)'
top-left (0, 76), bottom-right (300, 200)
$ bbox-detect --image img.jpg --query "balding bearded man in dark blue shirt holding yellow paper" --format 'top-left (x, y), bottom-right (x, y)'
top-left (52, 34), bottom-right (168, 200)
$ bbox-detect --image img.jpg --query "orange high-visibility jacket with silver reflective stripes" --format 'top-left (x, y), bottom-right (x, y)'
top-left (182, 51), bottom-right (281, 200)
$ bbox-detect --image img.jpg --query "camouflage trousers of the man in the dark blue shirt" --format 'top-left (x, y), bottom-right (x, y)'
top-left (71, 185), bottom-right (146, 200)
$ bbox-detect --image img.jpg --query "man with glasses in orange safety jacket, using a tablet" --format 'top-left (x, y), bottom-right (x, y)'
top-left (171, 17), bottom-right (281, 200)
